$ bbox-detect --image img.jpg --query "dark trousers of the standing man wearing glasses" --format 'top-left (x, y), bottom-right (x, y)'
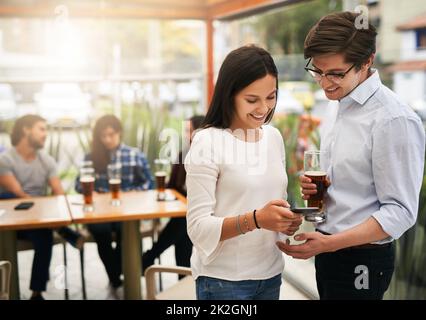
top-left (315, 243), bottom-right (395, 300)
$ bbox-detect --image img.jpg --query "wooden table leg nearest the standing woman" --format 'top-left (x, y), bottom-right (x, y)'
top-left (121, 220), bottom-right (142, 300)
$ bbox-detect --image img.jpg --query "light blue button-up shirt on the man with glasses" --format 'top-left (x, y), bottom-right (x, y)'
top-left (316, 70), bottom-right (425, 243)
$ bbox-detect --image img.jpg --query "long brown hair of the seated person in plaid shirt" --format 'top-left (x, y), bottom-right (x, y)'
top-left (90, 114), bottom-right (123, 173)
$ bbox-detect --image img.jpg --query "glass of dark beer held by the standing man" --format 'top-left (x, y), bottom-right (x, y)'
top-left (304, 150), bottom-right (327, 223)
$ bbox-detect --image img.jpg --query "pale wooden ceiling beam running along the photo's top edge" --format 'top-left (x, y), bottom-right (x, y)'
top-left (0, 0), bottom-right (304, 20)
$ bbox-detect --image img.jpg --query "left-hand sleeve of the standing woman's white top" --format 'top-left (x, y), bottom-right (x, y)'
top-left (185, 131), bottom-right (224, 262)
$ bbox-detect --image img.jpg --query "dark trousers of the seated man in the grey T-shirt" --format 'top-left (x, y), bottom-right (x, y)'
top-left (17, 229), bottom-right (53, 292)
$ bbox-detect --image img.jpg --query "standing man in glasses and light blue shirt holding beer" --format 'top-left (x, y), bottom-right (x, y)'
top-left (278, 12), bottom-right (425, 299)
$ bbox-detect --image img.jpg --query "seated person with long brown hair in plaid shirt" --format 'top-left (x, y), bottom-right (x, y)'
top-left (76, 115), bottom-right (154, 298)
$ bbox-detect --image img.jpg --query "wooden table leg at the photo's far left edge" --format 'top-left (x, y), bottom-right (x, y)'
top-left (0, 230), bottom-right (20, 300)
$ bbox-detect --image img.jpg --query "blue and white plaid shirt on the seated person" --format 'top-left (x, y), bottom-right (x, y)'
top-left (75, 144), bottom-right (154, 193)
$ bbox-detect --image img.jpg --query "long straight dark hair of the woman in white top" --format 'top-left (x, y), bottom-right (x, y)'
top-left (203, 45), bottom-right (278, 129)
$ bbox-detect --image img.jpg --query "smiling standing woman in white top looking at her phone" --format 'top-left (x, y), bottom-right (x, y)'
top-left (185, 46), bottom-right (302, 300)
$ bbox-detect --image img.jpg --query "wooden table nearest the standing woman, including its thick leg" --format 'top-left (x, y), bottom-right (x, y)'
top-left (67, 189), bottom-right (187, 300)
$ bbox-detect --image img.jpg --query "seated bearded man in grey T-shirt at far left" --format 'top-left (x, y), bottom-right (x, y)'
top-left (0, 115), bottom-right (83, 300)
